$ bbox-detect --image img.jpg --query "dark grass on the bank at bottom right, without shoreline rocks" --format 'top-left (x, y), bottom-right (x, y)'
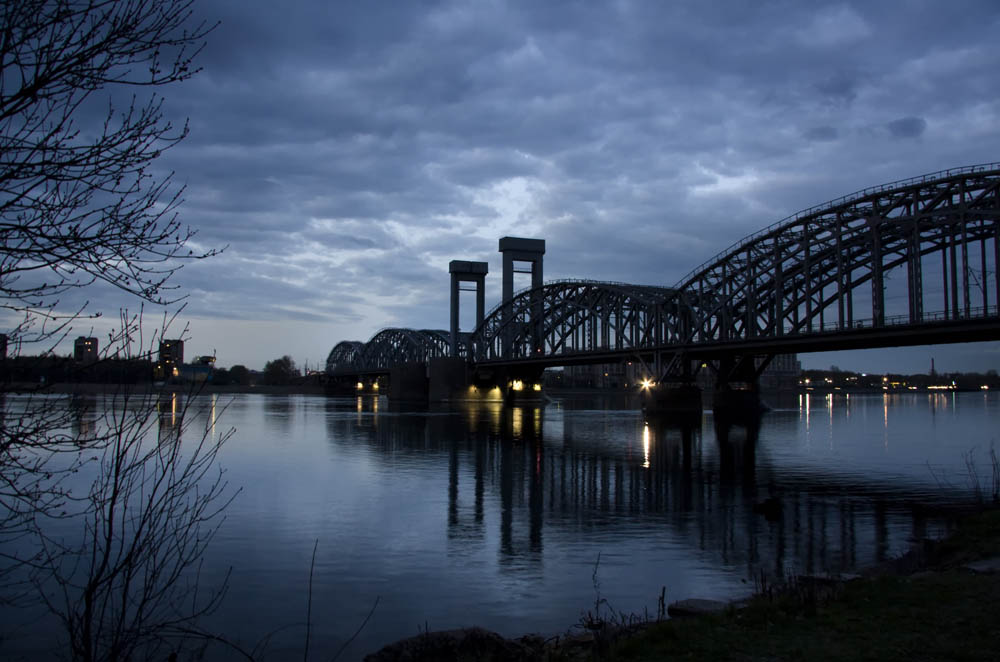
top-left (607, 510), bottom-right (1000, 662)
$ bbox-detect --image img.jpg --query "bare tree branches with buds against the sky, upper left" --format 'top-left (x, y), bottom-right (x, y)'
top-left (0, 0), bottom-right (219, 349)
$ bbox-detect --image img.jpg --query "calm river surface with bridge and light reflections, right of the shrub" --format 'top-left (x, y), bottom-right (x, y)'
top-left (1, 393), bottom-right (1000, 659)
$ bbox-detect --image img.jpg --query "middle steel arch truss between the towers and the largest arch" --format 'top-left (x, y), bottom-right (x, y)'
top-left (472, 281), bottom-right (680, 362)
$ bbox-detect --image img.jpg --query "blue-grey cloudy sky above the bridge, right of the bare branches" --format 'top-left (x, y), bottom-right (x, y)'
top-left (82, 0), bottom-right (1000, 371)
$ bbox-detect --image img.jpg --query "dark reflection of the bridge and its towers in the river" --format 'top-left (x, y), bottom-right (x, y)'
top-left (327, 396), bottom-right (948, 577)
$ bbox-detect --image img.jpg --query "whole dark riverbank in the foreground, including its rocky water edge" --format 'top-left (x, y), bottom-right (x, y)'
top-left (364, 508), bottom-right (1000, 662)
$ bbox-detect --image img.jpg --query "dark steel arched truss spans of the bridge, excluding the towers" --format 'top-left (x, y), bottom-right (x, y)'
top-left (328, 163), bottom-right (1000, 382)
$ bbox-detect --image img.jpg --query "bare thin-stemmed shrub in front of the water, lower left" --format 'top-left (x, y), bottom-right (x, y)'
top-left (32, 386), bottom-right (236, 662)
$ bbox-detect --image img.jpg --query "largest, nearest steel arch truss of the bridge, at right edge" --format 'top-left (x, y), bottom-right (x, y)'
top-left (677, 164), bottom-right (1000, 344)
